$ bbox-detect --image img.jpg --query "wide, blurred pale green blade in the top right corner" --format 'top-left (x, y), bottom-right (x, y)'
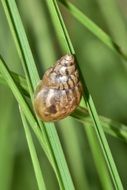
top-left (97, 0), bottom-right (127, 55)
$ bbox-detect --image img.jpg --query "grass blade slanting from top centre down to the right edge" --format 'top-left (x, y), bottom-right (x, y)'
top-left (59, 0), bottom-right (127, 60)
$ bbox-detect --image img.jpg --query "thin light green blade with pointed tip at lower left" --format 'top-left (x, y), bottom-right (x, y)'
top-left (19, 107), bottom-right (46, 190)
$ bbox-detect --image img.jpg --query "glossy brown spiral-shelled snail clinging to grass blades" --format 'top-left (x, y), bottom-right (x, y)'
top-left (34, 54), bottom-right (82, 121)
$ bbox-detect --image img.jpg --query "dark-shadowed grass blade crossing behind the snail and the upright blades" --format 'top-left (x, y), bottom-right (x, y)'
top-left (0, 71), bottom-right (127, 142)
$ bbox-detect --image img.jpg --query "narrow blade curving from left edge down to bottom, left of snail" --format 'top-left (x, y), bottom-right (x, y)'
top-left (0, 58), bottom-right (70, 189)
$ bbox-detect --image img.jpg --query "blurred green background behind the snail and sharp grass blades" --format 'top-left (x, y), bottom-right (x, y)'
top-left (0, 0), bottom-right (127, 190)
